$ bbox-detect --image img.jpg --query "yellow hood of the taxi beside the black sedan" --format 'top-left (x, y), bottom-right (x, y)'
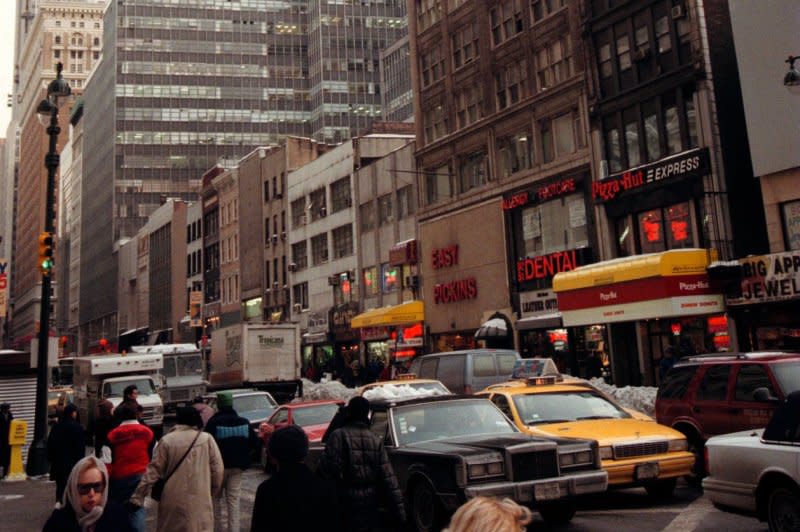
top-left (526, 418), bottom-right (685, 446)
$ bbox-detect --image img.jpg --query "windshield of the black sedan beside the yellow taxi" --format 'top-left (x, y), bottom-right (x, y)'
top-left (392, 399), bottom-right (517, 445)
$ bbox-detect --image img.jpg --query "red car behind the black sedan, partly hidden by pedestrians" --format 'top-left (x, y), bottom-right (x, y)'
top-left (258, 400), bottom-right (344, 466)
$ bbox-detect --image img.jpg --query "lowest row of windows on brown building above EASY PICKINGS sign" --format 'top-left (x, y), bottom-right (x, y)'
top-left (423, 110), bottom-right (587, 205)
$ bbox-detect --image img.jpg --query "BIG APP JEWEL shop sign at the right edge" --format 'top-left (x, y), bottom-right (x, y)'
top-left (725, 251), bottom-right (800, 305)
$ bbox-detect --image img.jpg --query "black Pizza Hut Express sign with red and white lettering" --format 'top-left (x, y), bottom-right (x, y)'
top-left (592, 148), bottom-right (710, 203)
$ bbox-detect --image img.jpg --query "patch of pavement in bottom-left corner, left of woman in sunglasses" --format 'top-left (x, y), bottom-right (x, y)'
top-left (0, 475), bottom-right (56, 532)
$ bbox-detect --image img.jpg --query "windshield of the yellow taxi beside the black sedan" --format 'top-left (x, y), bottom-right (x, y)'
top-left (514, 391), bottom-right (631, 425)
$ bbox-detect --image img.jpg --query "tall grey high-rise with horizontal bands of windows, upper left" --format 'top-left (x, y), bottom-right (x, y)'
top-left (80, 0), bottom-right (406, 349)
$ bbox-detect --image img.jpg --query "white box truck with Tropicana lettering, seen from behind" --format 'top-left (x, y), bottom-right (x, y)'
top-left (208, 323), bottom-right (303, 402)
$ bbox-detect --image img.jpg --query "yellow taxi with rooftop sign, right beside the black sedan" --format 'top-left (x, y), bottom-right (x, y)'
top-left (477, 359), bottom-right (694, 497)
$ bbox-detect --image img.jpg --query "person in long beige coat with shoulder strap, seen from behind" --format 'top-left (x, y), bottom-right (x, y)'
top-left (130, 407), bottom-right (225, 532)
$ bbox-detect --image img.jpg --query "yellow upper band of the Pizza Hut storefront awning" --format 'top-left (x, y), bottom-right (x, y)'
top-left (553, 249), bottom-right (717, 292)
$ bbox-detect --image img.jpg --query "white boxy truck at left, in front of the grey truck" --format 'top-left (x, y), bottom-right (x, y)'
top-left (72, 353), bottom-right (164, 434)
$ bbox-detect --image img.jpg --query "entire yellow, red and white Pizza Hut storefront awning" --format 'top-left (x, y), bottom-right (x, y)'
top-left (553, 249), bottom-right (724, 326)
